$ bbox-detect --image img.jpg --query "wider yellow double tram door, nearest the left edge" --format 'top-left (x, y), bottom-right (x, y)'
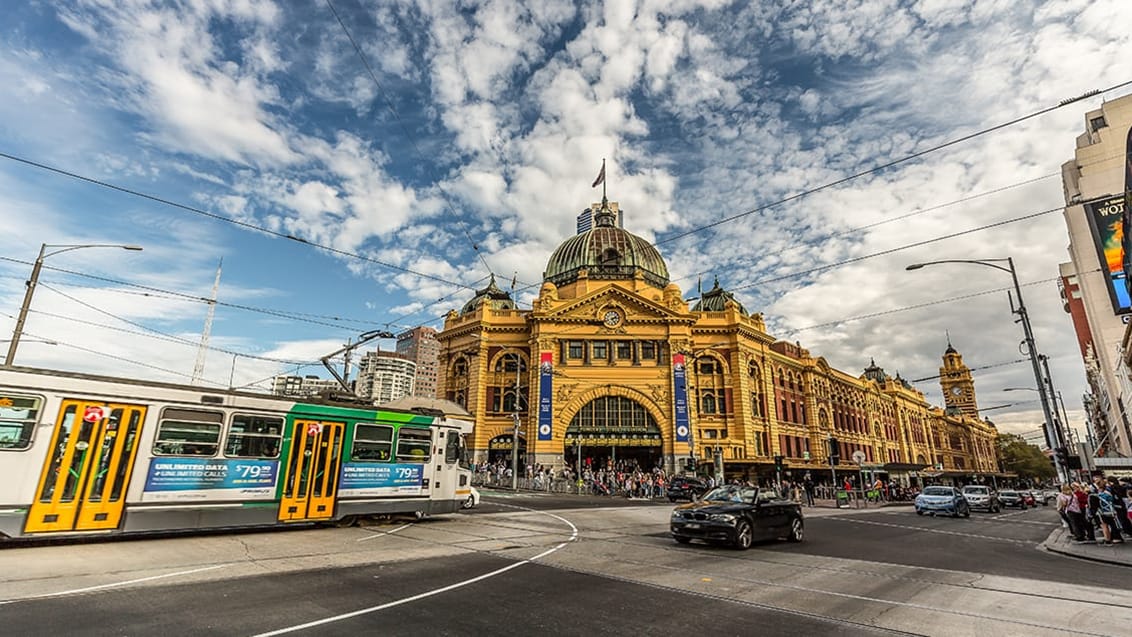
top-left (24, 401), bottom-right (146, 533)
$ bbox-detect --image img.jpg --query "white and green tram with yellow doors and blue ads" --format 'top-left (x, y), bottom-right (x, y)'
top-left (0, 367), bottom-right (472, 539)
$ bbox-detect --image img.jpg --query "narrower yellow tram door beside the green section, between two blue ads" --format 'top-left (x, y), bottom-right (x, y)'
top-left (280, 420), bottom-right (345, 522)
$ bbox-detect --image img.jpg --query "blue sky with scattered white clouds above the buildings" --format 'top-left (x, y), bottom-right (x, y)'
top-left (0, 0), bottom-right (1132, 441)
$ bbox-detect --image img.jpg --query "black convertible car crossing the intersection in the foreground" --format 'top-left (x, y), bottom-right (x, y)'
top-left (670, 485), bottom-right (804, 550)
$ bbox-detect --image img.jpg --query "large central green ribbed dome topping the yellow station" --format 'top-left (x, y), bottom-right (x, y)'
top-left (542, 207), bottom-right (668, 289)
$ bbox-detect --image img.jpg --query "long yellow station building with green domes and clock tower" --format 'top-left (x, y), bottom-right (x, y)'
top-left (437, 201), bottom-right (998, 482)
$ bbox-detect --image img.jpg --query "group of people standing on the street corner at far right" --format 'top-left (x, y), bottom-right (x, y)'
top-left (1057, 474), bottom-right (1132, 546)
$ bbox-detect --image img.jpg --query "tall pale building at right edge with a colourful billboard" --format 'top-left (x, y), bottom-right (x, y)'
top-left (1061, 95), bottom-right (1132, 456)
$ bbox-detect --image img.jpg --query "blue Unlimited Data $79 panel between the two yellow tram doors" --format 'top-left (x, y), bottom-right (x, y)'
top-left (145, 458), bottom-right (278, 492)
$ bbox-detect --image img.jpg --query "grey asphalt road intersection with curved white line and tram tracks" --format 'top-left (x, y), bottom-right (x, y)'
top-left (0, 493), bottom-right (1132, 637)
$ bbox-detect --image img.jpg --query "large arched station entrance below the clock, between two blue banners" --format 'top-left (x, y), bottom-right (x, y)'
top-left (563, 396), bottom-right (663, 471)
